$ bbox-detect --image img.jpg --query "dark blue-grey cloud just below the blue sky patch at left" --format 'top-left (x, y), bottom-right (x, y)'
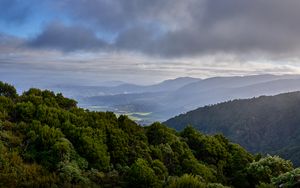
top-left (28, 22), bottom-right (107, 52)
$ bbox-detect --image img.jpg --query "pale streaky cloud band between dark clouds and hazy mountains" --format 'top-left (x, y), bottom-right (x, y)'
top-left (0, 30), bottom-right (300, 88)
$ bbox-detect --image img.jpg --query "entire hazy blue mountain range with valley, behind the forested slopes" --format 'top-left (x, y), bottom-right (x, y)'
top-left (79, 75), bottom-right (300, 123)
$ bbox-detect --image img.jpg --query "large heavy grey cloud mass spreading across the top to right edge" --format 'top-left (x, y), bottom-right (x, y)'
top-left (4, 0), bottom-right (300, 58)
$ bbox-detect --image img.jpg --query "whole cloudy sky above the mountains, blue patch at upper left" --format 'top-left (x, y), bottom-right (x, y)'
top-left (0, 0), bottom-right (300, 86)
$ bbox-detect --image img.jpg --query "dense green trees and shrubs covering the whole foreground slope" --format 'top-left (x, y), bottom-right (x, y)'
top-left (0, 82), bottom-right (300, 188)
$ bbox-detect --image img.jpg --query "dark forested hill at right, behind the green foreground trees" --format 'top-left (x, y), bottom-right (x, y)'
top-left (165, 92), bottom-right (300, 166)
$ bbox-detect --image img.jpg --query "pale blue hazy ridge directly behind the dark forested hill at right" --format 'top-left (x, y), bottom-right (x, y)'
top-left (165, 78), bottom-right (300, 110)
